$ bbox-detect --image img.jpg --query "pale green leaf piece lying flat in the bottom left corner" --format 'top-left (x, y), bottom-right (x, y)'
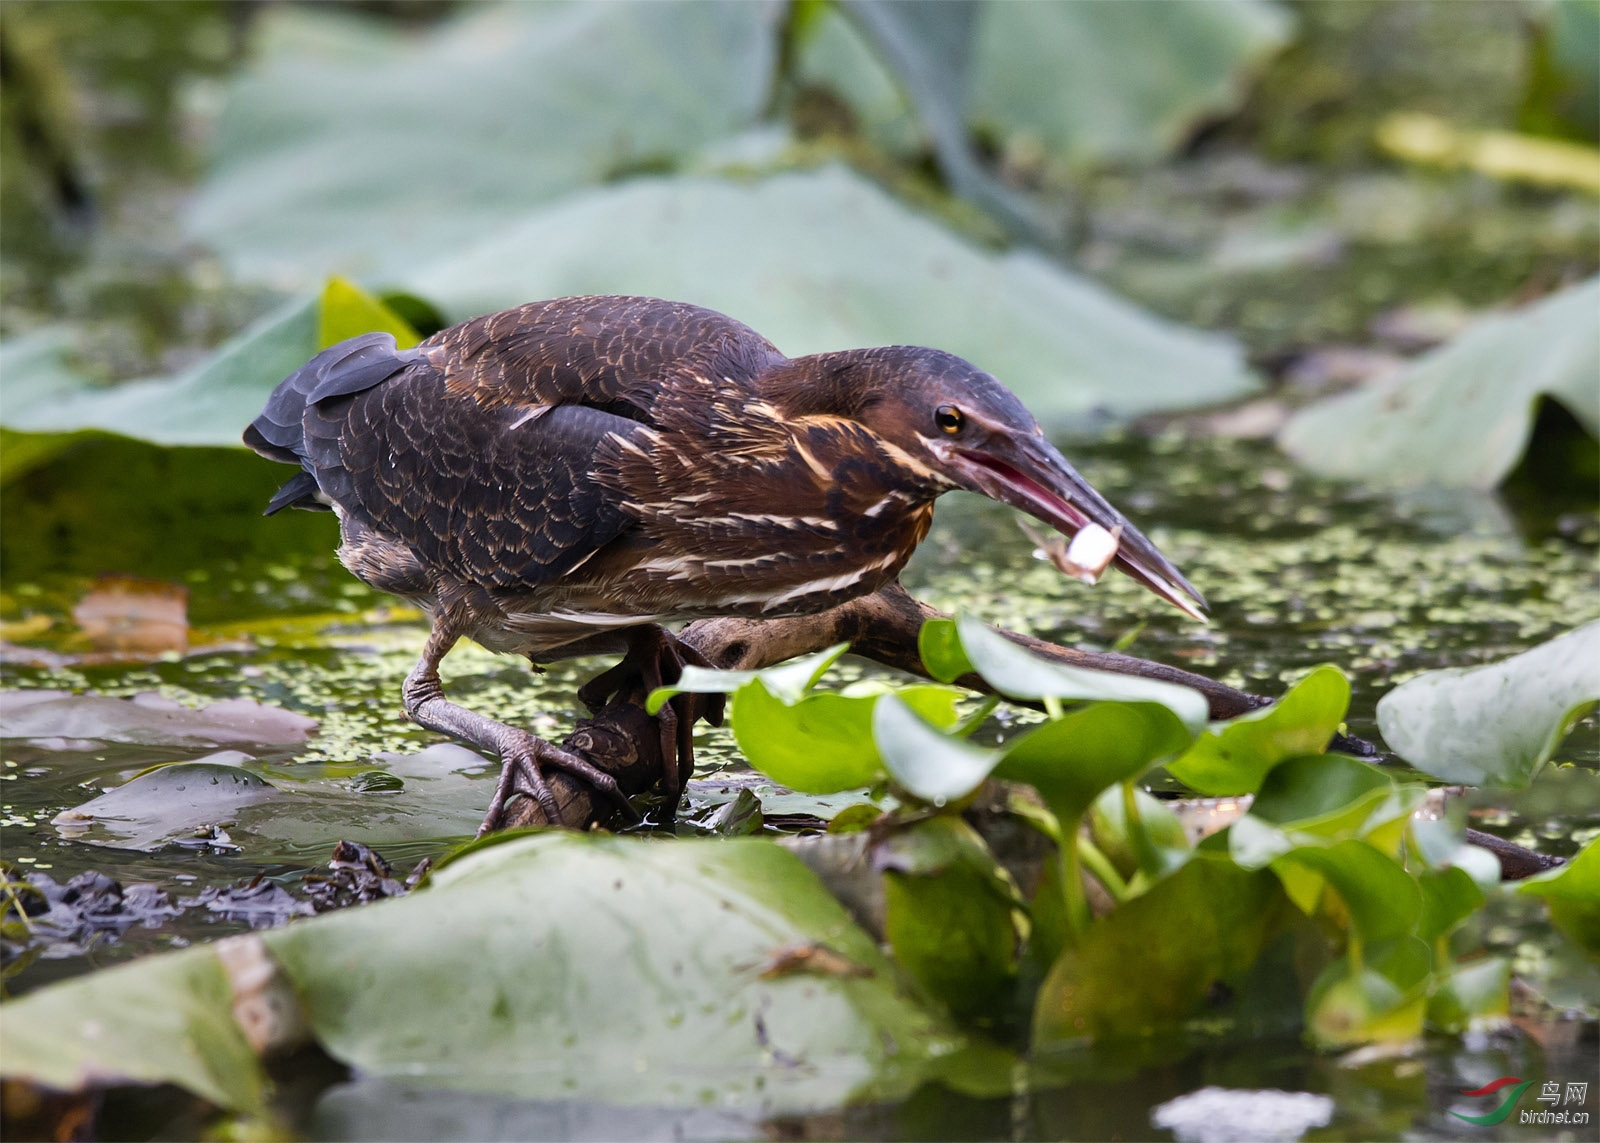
top-left (0, 948), bottom-right (266, 1113)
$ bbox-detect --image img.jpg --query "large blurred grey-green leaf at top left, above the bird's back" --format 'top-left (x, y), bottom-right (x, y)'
top-left (189, 0), bottom-right (781, 284)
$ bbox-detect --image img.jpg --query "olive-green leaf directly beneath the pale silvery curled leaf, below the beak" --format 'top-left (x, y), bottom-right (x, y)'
top-left (995, 703), bottom-right (1190, 829)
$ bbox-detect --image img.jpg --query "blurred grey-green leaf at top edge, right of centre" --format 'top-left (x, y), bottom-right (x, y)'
top-left (971, 0), bottom-right (1293, 162)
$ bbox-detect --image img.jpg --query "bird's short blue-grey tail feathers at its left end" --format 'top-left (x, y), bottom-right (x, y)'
top-left (245, 333), bottom-right (419, 515)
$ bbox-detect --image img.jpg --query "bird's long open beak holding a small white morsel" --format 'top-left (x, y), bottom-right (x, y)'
top-left (946, 432), bottom-right (1206, 621)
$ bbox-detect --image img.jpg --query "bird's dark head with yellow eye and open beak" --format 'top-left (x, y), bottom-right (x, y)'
top-left (768, 346), bottom-right (1206, 620)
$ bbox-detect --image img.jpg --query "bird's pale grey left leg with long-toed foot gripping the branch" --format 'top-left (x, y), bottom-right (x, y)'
top-left (403, 615), bottom-right (632, 837)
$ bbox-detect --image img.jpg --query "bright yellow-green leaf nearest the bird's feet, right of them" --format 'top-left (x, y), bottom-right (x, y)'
top-left (728, 679), bottom-right (960, 794)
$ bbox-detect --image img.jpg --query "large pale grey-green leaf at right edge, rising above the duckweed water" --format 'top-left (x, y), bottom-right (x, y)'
top-left (1278, 279), bottom-right (1600, 488)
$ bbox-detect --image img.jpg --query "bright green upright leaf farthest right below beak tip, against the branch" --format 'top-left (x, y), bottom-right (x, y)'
top-left (1166, 666), bottom-right (1350, 796)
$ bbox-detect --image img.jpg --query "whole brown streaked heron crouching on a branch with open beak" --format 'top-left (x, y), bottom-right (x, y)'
top-left (245, 298), bottom-right (1205, 828)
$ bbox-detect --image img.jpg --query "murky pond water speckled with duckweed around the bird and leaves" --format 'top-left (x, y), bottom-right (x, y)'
top-left (0, 425), bottom-right (1600, 1138)
